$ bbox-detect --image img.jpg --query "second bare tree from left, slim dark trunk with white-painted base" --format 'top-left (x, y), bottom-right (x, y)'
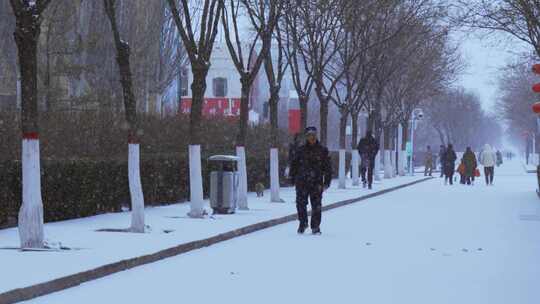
top-left (103, 0), bottom-right (145, 233)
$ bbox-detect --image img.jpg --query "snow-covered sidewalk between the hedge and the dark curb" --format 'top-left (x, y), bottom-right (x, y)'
top-left (0, 176), bottom-right (423, 294)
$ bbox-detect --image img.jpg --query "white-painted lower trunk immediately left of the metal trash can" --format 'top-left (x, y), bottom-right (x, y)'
top-left (188, 145), bottom-right (205, 218)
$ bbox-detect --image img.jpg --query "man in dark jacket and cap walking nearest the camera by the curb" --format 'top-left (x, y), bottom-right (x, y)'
top-left (290, 127), bottom-right (332, 234)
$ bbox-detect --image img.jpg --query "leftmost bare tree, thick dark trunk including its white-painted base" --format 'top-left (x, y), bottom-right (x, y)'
top-left (10, 0), bottom-right (52, 248)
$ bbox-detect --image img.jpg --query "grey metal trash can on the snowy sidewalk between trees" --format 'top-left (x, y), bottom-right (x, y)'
top-left (208, 155), bottom-right (240, 214)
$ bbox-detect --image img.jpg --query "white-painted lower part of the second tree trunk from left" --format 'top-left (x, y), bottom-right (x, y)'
top-left (128, 143), bottom-right (144, 233)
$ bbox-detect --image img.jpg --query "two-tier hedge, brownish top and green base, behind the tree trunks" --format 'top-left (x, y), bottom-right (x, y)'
top-left (0, 111), bottom-right (296, 226)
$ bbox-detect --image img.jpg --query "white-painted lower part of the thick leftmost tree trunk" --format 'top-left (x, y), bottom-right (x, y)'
top-left (19, 136), bottom-right (44, 248)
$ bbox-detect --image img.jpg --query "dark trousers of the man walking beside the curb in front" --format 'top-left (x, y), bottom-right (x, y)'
top-left (296, 186), bottom-right (323, 229)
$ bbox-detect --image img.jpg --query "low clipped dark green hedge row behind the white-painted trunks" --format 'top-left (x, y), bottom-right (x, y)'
top-left (0, 150), bottom-right (292, 226)
